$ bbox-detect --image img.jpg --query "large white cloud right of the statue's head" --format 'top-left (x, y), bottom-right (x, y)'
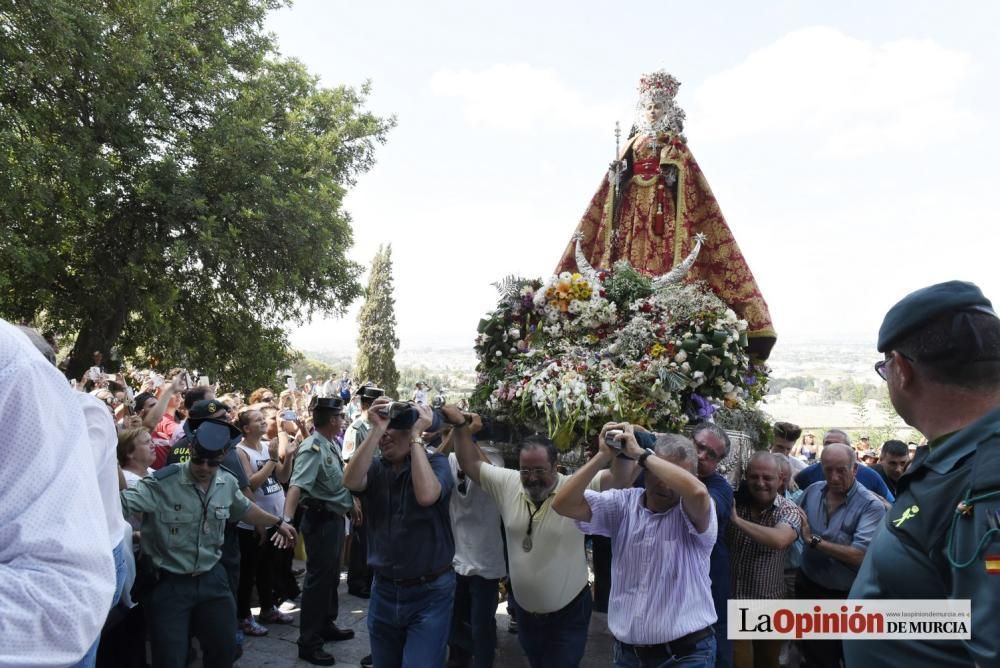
top-left (689, 27), bottom-right (980, 158)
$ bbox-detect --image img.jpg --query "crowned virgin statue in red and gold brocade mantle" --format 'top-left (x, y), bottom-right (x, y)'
top-left (556, 70), bottom-right (776, 360)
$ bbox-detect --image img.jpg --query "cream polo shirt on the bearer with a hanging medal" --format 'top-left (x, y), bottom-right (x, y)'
top-left (479, 464), bottom-right (601, 613)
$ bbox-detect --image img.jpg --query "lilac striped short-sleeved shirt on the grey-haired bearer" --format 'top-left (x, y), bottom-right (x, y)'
top-left (576, 488), bottom-right (718, 645)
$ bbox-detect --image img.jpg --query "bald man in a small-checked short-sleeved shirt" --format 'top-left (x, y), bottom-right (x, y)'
top-left (726, 452), bottom-right (801, 668)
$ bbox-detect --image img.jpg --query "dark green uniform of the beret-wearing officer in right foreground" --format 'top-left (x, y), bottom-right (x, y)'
top-left (844, 409), bottom-right (1000, 668)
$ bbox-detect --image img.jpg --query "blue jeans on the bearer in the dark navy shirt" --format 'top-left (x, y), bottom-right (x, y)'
top-left (368, 571), bottom-right (455, 668)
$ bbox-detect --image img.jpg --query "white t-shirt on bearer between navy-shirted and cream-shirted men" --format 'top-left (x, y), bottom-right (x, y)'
top-left (448, 452), bottom-right (504, 580)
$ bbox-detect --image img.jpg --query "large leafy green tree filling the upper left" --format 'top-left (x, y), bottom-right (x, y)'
top-left (0, 0), bottom-right (394, 388)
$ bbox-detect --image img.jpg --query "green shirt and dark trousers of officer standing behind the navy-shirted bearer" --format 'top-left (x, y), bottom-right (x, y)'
top-left (289, 432), bottom-right (354, 652)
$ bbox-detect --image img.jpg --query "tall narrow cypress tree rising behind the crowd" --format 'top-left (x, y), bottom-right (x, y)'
top-left (354, 244), bottom-right (399, 397)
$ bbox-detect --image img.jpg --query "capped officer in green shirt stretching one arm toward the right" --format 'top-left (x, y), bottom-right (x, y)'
top-left (121, 419), bottom-right (295, 668)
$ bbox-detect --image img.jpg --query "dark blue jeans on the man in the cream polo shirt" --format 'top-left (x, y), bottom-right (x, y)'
top-left (514, 586), bottom-right (594, 668)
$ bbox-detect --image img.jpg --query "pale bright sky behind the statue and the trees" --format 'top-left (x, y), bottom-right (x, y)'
top-left (267, 0), bottom-right (1000, 356)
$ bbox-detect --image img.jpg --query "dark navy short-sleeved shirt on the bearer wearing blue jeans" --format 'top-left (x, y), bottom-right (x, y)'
top-left (359, 454), bottom-right (455, 579)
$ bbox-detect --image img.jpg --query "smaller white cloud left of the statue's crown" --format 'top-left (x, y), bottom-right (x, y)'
top-left (430, 63), bottom-right (626, 132)
